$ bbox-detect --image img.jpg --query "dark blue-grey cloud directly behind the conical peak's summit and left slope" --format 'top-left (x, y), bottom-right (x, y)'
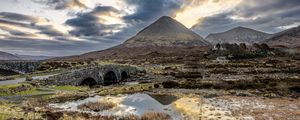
top-left (115, 0), bottom-right (183, 41)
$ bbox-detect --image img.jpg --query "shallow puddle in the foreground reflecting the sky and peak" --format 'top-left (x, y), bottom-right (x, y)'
top-left (49, 93), bottom-right (183, 120)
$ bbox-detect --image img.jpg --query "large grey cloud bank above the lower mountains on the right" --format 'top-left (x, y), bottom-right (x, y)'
top-left (192, 0), bottom-right (300, 36)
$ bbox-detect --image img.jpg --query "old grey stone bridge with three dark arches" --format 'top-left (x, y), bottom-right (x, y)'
top-left (46, 65), bottom-right (142, 86)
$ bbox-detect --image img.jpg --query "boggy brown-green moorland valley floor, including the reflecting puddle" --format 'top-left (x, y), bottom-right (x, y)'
top-left (0, 58), bottom-right (300, 120)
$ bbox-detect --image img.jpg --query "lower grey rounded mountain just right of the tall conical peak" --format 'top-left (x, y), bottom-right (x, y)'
top-left (205, 27), bottom-right (272, 44)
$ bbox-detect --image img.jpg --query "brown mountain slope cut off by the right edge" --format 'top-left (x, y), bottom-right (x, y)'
top-left (263, 26), bottom-right (300, 48)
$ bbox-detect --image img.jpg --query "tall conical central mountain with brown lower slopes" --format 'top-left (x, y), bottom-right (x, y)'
top-left (51, 16), bottom-right (210, 61)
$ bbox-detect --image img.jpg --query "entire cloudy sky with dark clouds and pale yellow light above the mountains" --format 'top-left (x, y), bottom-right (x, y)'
top-left (0, 0), bottom-right (300, 56)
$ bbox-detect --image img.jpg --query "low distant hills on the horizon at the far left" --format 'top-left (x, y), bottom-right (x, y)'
top-left (0, 51), bottom-right (52, 60)
